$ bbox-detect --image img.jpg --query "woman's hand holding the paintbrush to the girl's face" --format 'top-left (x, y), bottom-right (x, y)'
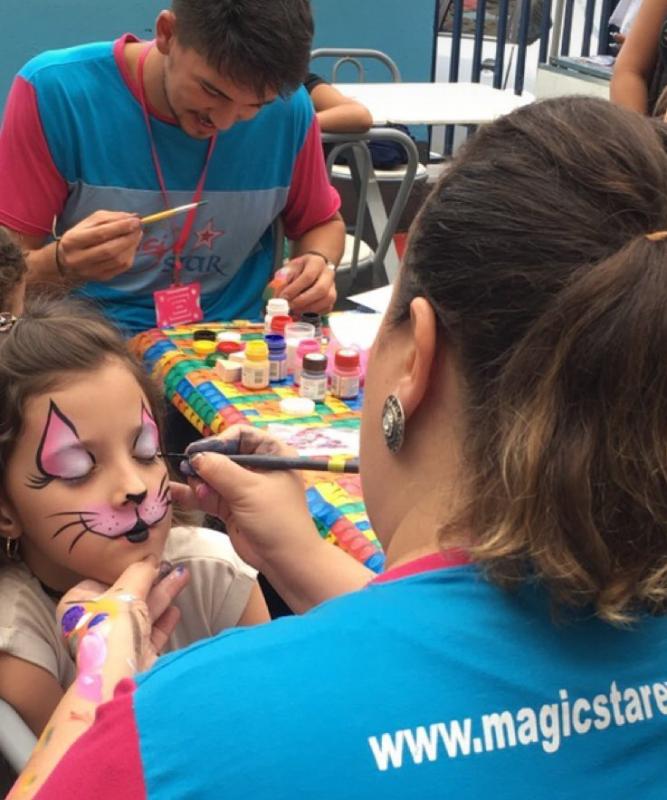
top-left (171, 425), bottom-right (320, 571)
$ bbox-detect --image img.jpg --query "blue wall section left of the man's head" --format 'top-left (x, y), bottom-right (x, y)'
top-left (0, 0), bottom-right (157, 110)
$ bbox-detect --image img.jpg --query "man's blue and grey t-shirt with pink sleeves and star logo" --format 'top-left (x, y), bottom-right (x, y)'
top-left (0, 35), bottom-right (339, 332)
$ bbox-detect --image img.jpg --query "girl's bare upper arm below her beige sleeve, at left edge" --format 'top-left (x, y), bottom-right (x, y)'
top-left (0, 653), bottom-right (63, 736)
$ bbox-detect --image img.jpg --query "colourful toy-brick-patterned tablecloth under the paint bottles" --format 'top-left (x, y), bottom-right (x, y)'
top-left (129, 320), bottom-right (384, 572)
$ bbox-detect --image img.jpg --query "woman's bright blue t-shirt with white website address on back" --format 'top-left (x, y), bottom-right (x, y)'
top-left (38, 566), bottom-right (667, 800)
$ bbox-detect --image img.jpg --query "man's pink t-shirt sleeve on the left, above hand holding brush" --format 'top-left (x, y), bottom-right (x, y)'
top-left (0, 75), bottom-right (67, 236)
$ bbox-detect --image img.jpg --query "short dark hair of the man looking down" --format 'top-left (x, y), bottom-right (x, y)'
top-left (172, 0), bottom-right (313, 96)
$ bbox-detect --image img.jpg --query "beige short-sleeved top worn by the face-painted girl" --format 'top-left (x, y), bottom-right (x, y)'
top-left (0, 527), bottom-right (257, 689)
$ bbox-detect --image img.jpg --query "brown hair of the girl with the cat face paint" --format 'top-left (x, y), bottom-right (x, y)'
top-left (0, 297), bottom-right (163, 488)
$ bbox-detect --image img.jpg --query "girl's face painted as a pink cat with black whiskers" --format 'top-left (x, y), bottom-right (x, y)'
top-left (2, 360), bottom-right (171, 589)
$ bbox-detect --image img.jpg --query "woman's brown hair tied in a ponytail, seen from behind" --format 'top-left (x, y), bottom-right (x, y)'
top-left (393, 97), bottom-right (667, 623)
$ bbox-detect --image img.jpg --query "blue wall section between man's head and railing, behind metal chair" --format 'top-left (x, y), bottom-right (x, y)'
top-left (311, 0), bottom-right (438, 83)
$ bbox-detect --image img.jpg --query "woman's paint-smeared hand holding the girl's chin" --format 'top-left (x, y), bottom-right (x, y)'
top-left (57, 558), bottom-right (189, 671)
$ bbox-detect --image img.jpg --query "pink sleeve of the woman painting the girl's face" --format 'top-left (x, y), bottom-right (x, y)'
top-left (35, 679), bottom-right (147, 800)
